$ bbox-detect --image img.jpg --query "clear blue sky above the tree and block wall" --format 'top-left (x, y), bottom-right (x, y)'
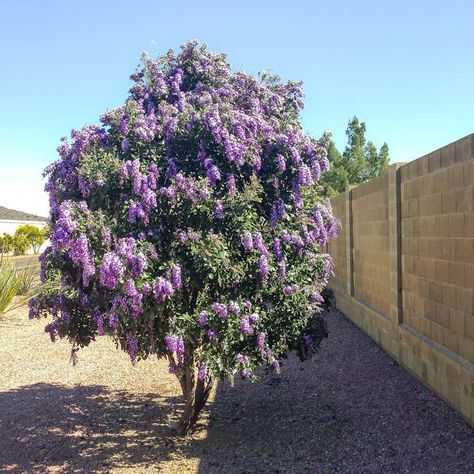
top-left (0, 0), bottom-right (474, 215)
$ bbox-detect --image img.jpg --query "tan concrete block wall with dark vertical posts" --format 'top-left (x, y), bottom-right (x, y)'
top-left (329, 135), bottom-right (474, 425)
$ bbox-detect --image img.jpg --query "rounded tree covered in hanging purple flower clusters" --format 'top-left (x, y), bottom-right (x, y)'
top-left (30, 42), bottom-right (336, 434)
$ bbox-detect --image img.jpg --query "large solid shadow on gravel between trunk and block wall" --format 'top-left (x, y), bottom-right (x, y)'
top-left (199, 311), bottom-right (474, 474)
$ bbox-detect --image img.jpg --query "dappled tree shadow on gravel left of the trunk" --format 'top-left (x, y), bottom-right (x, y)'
top-left (0, 384), bottom-right (190, 472)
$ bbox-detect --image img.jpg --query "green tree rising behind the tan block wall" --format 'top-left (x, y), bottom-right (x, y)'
top-left (322, 116), bottom-right (390, 196)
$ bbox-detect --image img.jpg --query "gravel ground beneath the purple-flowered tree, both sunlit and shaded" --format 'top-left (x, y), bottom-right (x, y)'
top-left (0, 309), bottom-right (474, 474)
